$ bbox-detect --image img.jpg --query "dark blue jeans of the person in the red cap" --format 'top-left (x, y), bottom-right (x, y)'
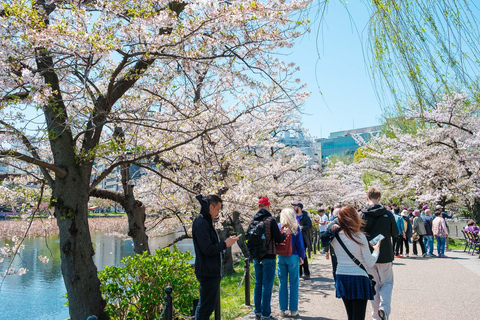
top-left (253, 259), bottom-right (277, 318)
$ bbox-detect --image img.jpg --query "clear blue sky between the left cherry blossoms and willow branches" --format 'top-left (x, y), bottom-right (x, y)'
top-left (287, 0), bottom-right (382, 138)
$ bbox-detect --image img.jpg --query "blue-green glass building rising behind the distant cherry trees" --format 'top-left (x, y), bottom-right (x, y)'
top-left (314, 126), bottom-right (382, 163)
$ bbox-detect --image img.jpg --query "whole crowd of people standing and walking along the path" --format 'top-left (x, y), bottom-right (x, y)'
top-left (188, 188), bottom-right (478, 320)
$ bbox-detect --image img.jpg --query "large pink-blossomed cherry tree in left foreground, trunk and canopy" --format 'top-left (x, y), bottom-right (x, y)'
top-left (0, 0), bottom-right (306, 319)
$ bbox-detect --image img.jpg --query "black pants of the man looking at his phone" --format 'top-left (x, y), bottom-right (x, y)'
top-left (195, 277), bottom-right (222, 320)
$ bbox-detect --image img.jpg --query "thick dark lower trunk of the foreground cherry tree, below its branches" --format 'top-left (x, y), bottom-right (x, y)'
top-left (52, 167), bottom-right (108, 320)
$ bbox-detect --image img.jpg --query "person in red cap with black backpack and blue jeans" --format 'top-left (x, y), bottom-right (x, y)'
top-left (245, 197), bottom-right (286, 320)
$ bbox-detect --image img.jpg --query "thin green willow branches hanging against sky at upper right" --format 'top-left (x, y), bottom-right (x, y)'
top-left (367, 0), bottom-right (480, 115)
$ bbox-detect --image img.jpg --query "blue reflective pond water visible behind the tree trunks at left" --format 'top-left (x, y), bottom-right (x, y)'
top-left (0, 234), bottom-right (194, 320)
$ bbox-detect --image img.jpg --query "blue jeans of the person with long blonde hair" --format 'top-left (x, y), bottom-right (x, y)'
top-left (278, 254), bottom-right (300, 311)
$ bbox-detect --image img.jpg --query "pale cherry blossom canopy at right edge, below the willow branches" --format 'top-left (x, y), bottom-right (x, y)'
top-left (354, 94), bottom-right (480, 221)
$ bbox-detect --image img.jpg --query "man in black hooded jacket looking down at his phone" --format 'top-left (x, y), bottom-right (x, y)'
top-left (192, 195), bottom-right (238, 320)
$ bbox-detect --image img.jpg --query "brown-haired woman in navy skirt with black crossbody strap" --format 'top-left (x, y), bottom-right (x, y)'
top-left (331, 206), bottom-right (380, 320)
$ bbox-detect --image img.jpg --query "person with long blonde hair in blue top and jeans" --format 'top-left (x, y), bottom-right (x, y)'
top-left (278, 208), bottom-right (305, 317)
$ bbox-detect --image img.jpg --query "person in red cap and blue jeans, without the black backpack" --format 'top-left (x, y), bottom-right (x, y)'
top-left (253, 197), bottom-right (286, 320)
